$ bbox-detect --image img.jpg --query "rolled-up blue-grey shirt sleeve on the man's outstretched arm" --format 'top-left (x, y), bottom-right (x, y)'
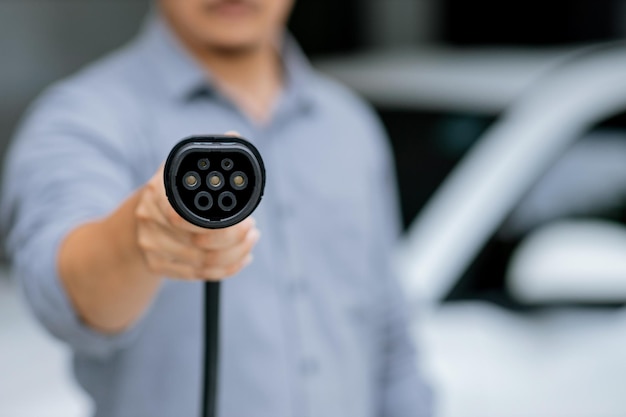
top-left (0, 83), bottom-right (145, 357)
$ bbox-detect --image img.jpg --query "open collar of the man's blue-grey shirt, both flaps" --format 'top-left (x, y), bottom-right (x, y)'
top-left (138, 10), bottom-right (314, 107)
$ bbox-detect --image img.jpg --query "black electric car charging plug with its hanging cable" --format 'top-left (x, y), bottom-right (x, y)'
top-left (163, 135), bottom-right (265, 417)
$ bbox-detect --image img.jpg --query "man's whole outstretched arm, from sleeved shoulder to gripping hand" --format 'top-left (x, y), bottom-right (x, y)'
top-left (0, 85), bottom-right (258, 356)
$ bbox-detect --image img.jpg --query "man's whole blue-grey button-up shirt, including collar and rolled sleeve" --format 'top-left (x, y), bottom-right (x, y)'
top-left (2, 12), bottom-right (430, 417)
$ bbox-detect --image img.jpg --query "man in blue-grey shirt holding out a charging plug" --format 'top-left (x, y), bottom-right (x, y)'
top-left (2, 0), bottom-right (430, 417)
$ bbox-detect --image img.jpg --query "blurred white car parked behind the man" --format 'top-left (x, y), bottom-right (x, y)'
top-left (318, 44), bottom-right (626, 417)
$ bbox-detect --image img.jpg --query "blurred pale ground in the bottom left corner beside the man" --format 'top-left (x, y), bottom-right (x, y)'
top-left (0, 268), bottom-right (90, 417)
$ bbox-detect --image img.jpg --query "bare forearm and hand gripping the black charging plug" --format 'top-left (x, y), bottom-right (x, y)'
top-left (59, 170), bottom-right (259, 333)
